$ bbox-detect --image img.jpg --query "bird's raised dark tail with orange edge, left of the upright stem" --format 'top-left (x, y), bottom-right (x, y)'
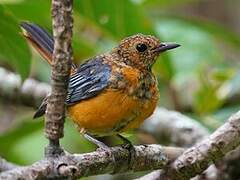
top-left (20, 22), bottom-right (76, 70)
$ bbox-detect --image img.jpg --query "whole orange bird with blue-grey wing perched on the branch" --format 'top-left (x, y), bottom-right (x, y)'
top-left (21, 22), bottom-right (179, 148)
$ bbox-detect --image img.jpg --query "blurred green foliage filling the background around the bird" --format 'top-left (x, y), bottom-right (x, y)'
top-left (0, 0), bottom-right (240, 171)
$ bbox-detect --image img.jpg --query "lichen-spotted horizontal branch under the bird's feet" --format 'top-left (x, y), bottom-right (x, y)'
top-left (0, 145), bottom-right (183, 180)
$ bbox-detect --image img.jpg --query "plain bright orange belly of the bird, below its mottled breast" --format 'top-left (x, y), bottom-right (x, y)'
top-left (68, 90), bottom-right (158, 136)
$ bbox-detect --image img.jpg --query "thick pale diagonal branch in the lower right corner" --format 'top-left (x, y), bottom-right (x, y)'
top-left (163, 111), bottom-right (240, 180)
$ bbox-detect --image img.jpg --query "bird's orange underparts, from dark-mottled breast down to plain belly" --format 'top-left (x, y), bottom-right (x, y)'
top-left (68, 54), bottom-right (158, 136)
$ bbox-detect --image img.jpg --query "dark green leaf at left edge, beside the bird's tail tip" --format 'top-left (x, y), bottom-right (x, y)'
top-left (0, 5), bottom-right (31, 79)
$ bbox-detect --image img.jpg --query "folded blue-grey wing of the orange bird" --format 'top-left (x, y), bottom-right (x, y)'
top-left (66, 58), bottom-right (111, 105)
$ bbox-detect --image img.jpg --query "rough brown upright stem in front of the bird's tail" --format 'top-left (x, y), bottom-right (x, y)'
top-left (45, 0), bottom-right (73, 156)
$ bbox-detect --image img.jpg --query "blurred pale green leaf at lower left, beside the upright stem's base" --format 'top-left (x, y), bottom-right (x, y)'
top-left (0, 118), bottom-right (46, 164)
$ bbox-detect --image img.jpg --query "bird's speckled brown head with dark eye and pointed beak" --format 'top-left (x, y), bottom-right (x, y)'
top-left (114, 34), bottom-right (180, 69)
